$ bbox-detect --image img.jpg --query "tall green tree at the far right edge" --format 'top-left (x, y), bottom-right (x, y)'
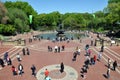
top-left (105, 0), bottom-right (120, 30)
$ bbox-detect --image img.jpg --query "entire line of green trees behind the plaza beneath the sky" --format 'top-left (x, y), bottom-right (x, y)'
top-left (0, 0), bottom-right (120, 35)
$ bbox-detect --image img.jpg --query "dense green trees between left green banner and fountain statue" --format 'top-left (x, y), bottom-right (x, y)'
top-left (34, 12), bottom-right (61, 29)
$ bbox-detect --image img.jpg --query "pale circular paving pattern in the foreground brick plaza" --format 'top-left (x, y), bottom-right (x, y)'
top-left (36, 64), bottom-right (78, 80)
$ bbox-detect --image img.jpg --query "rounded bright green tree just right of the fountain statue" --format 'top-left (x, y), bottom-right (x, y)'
top-left (63, 13), bottom-right (86, 30)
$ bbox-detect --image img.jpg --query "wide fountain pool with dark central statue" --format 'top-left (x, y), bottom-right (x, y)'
top-left (36, 24), bottom-right (85, 41)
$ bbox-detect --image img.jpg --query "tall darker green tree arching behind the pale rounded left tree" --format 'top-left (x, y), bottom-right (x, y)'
top-left (4, 1), bottom-right (37, 30)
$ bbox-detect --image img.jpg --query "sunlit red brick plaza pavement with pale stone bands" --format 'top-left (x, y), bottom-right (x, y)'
top-left (0, 32), bottom-right (120, 80)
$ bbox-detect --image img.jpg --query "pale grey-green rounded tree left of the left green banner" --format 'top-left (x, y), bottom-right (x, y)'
top-left (8, 8), bottom-right (29, 33)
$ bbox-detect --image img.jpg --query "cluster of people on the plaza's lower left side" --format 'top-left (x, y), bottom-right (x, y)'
top-left (0, 47), bottom-right (36, 77)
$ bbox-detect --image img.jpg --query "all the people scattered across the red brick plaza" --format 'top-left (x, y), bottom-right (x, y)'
top-left (0, 31), bottom-right (118, 80)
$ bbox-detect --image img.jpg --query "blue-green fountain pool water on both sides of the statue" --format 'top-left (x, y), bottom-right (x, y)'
top-left (37, 32), bottom-right (85, 40)
